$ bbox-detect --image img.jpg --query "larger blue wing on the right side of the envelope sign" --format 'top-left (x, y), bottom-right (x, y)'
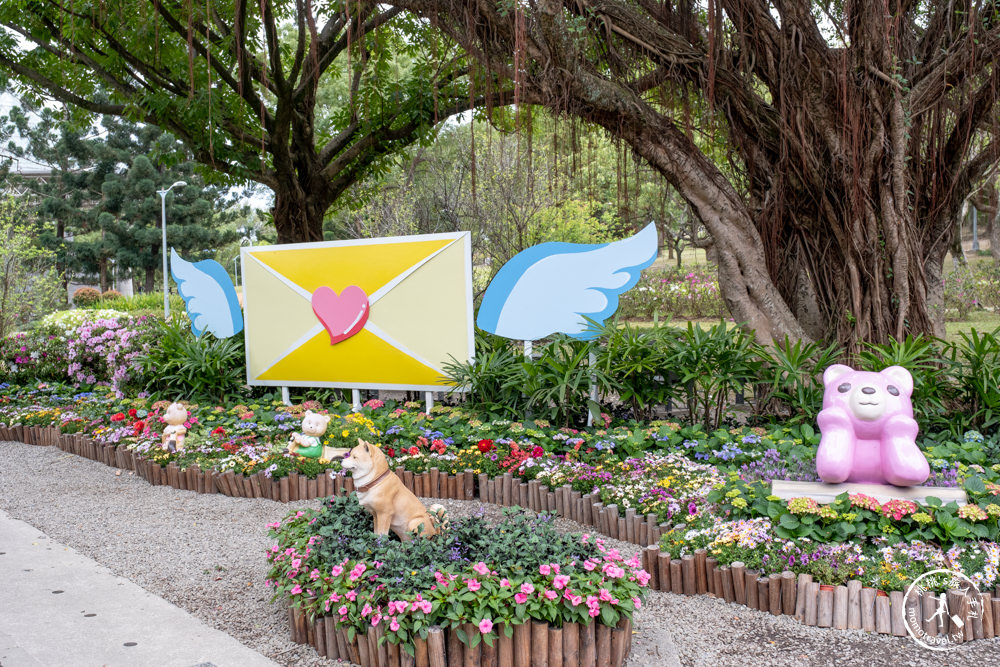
top-left (476, 223), bottom-right (659, 340)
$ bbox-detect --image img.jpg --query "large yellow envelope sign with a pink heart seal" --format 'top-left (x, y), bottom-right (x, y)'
top-left (241, 232), bottom-right (474, 391)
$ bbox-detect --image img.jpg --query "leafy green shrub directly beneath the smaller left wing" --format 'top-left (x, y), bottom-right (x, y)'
top-left (140, 318), bottom-right (246, 405)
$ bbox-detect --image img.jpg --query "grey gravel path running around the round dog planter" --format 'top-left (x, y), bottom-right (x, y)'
top-left (0, 442), bottom-right (1000, 667)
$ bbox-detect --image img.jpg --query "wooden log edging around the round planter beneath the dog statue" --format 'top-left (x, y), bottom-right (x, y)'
top-left (288, 607), bottom-right (632, 667)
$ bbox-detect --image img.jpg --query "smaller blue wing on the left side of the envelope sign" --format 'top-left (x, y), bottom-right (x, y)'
top-left (170, 248), bottom-right (243, 338)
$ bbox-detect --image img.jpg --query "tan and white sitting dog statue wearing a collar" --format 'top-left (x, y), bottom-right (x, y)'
top-left (341, 438), bottom-right (446, 542)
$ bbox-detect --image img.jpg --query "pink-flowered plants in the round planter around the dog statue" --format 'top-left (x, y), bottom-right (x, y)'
top-left (267, 494), bottom-right (649, 653)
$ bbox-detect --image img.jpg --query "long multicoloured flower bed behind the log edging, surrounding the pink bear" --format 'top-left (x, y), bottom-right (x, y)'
top-left (0, 385), bottom-right (1000, 648)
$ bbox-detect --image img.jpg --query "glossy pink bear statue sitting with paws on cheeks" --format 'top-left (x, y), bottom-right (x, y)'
top-left (816, 364), bottom-right (930, 486)
